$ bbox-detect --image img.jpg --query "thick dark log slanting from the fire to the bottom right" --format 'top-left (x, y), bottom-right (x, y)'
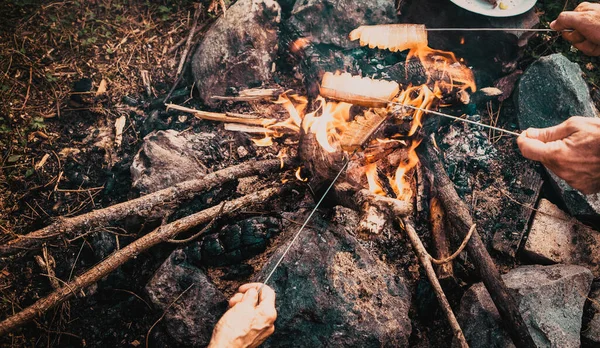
top-left (421, 143), bottom-right (536, 348)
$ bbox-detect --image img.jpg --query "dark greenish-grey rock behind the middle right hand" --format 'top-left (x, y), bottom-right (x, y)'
top-left (516, 54), bottom-right (600, 217)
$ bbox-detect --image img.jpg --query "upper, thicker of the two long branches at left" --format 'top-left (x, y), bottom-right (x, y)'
top-left (0, 159), bottom-right (293, 256)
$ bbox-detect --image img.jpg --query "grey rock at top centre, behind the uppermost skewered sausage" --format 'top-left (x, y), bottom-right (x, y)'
top-left (288, 0), bottom-right (396, 48)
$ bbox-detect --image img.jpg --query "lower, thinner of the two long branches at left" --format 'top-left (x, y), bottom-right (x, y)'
top-left (0, 188), bottom-right (280, 336)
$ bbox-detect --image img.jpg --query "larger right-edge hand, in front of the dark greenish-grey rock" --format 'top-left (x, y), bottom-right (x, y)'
top-left (517, 116), bottom-right (600, 194)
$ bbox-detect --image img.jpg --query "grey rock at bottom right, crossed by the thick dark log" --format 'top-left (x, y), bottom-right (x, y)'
top-left (457, 265), bottom-right (593, 348)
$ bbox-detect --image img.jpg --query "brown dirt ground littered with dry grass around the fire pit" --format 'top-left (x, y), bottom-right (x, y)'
top-left (0, 0), bottom-right (600, 347)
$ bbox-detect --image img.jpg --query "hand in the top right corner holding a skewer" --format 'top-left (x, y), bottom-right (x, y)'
top-left (550, 2), bottom-right (600, 56)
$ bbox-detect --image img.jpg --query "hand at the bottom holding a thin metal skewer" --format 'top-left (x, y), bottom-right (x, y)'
top-left (208, 283), bottom-right (277, 348)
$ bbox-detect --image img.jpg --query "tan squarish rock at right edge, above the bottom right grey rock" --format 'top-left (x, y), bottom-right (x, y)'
top-left (523, 199), bottom-right (600, 277)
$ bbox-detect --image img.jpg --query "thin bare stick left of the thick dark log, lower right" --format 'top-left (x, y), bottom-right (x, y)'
top-left (398, 219), bottom-right (469, 348)
